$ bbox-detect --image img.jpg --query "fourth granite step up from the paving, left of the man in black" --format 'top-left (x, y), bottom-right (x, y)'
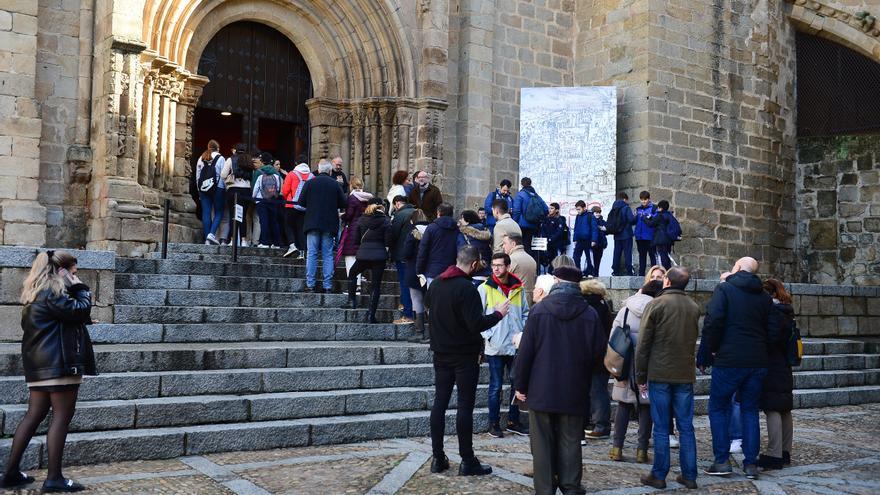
top-left (0, 341), bottom-right (431, 376)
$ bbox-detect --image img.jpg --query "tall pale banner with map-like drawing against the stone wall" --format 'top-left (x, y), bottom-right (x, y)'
top-left (519, 86), bottom-right (617, 276)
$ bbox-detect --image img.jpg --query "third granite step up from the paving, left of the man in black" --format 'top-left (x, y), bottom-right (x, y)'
top-left (0, 364), bottom-right (489, 404)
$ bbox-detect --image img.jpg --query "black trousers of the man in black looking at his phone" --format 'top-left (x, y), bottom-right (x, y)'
top-left (431, 352), bottom-right (478, 460)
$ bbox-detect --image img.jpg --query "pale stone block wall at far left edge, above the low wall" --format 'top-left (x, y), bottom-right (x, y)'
top-left (0, 0), bottom-right (46, 246)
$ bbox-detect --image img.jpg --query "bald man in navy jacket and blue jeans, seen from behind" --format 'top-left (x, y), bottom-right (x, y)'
top-left (703, 257), bottom-right (776, 479)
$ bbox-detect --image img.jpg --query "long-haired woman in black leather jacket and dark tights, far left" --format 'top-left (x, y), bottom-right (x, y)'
top-left (2, 251), bottom-right (97, 492)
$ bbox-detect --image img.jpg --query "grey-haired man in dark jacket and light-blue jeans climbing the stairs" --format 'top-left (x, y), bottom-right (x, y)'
top-left (299, 161), bottom-right (346, 292)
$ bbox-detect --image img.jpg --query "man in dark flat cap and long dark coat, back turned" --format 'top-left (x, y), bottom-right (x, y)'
top-left (514, 267), bottom-right (606, 495)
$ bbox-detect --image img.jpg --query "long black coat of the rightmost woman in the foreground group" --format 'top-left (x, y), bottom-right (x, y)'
top-left (760, 301), bottom-right (794, 412)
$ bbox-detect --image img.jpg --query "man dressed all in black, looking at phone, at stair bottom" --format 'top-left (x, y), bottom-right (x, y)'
top-left (426, 246), bottom-right (510, 476)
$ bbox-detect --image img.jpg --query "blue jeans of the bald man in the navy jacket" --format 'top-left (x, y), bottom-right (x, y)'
top-left (709, 366), bottom-right (767, 466)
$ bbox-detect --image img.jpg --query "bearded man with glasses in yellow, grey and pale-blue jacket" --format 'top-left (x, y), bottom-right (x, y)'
top-left (477, 253), bottom-right (529, 438)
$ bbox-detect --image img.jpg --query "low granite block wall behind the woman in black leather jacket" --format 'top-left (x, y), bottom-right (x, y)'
top-left (0, 246), bottom-right (116, 342)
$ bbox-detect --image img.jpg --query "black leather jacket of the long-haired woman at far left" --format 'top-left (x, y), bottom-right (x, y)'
top-left (21, 284), bottom-right (98, 382)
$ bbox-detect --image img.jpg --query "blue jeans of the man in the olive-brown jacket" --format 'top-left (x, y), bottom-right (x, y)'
top-left (648, 382), bottom-right (697, 481)
